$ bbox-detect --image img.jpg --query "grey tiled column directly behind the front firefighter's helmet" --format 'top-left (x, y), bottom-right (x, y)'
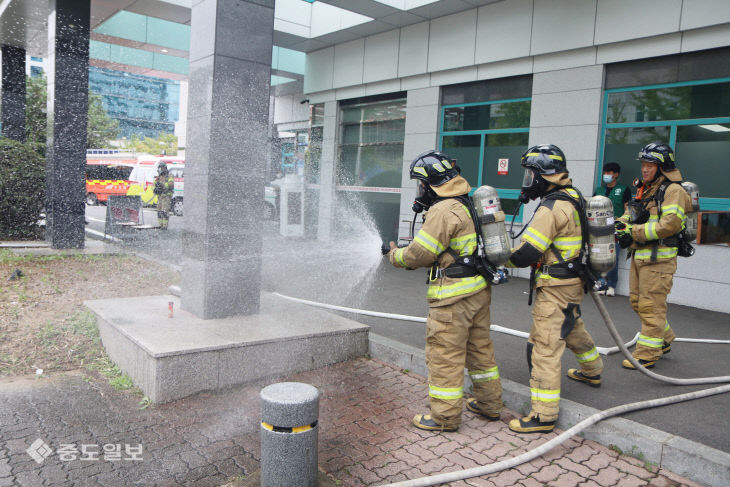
top-left (398, 87), bottom-right (441, 242)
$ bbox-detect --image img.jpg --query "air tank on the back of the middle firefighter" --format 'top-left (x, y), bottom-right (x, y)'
top-left (586, 196), bottom-right (616, 274)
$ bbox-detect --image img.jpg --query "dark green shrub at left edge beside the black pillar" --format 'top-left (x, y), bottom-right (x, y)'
top-left (0, 138), bottom-right (46, 240)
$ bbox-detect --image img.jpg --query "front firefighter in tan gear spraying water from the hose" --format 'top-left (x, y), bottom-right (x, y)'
top-left (388, 151), bottom-right (503, 431)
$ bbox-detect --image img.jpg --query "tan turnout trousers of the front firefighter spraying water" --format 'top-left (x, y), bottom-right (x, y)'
top-left (426, 287), bottom-right (502, 426)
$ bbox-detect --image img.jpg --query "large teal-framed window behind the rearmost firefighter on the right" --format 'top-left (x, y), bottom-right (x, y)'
top-left (596, 78), bottom-right (730, 211)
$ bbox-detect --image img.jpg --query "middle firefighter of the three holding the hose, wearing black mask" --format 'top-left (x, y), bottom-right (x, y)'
top-left (507, 145), bottom-right (603, 433)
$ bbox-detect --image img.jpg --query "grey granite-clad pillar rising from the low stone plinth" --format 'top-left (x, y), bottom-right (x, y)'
top-left (182, 0), bottom-right (274, 319)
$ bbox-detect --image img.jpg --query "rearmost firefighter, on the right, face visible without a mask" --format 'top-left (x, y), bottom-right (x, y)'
top-left (616, 142), bottom-right (691, 369)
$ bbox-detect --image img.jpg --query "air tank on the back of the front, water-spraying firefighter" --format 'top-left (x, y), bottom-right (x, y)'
top-left (472, 186), bottom-right (512, 266)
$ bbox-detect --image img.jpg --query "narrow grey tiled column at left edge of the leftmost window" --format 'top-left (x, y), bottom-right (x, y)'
top-left (317, 100), bottom-right (337, 242)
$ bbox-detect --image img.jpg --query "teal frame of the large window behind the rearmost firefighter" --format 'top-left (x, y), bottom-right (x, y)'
top-left (594, 77), bottom-right (730, 211)
